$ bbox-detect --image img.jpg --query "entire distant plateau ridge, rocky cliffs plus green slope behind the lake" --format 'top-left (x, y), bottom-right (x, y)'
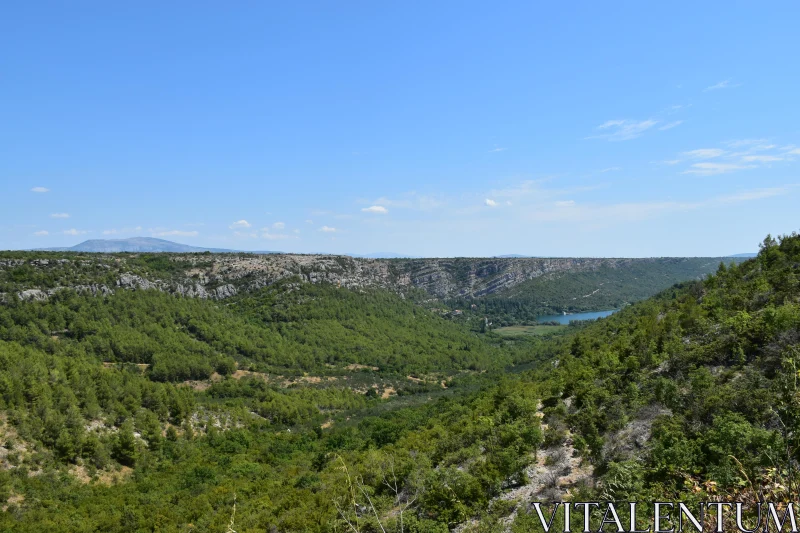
top-left (0, 248), bottom-right (731, 317)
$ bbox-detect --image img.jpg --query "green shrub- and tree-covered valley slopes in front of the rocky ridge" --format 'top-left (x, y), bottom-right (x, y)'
top-left (0, 235), bottom-right (800, 533)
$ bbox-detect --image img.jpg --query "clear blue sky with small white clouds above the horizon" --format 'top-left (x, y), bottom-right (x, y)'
top-left (0, 1), bottom-right (800, 257)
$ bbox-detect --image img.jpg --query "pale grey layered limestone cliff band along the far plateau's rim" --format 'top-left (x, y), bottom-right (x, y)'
top-left (0, 254), bottom-right (719, 300)
